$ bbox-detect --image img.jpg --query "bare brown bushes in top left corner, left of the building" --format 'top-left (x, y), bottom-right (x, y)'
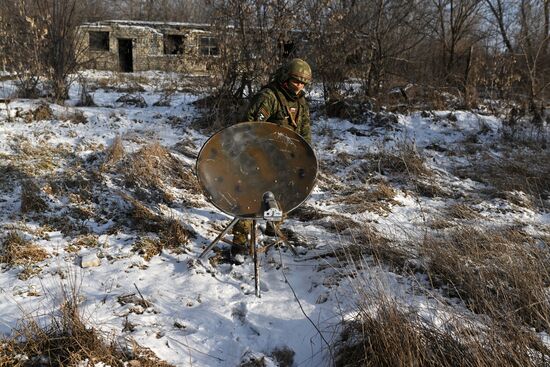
top-left (0, 0), bottom-right (91, 101)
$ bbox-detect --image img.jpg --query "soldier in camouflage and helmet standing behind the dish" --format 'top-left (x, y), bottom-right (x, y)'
top-left (232, 59), bottom-right (311, 254)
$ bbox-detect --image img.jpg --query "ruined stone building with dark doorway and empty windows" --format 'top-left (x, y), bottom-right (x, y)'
top-left (79, 20), bottom-right (219, 72)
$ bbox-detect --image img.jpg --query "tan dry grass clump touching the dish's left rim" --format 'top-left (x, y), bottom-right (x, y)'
top-left (125, 143), bottom-right (201, 197)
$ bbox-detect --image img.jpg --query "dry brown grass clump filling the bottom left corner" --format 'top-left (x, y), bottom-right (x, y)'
top-left (0, 288), bottom-right (175, 367)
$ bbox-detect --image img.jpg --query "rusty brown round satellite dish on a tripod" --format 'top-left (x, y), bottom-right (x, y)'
top-left (197, 122), bottom-right (318, 219)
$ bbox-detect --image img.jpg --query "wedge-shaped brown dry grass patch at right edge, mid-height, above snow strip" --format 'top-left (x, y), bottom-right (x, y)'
top-left (457, 149), bottom-right (550, 207)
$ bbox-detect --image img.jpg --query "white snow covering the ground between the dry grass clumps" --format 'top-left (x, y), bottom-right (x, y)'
top-left (0, 72), bottom-right (550, 367)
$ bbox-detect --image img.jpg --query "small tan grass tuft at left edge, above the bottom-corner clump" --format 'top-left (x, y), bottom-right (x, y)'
top-left (0, 232), bottom-right (49, 266)
